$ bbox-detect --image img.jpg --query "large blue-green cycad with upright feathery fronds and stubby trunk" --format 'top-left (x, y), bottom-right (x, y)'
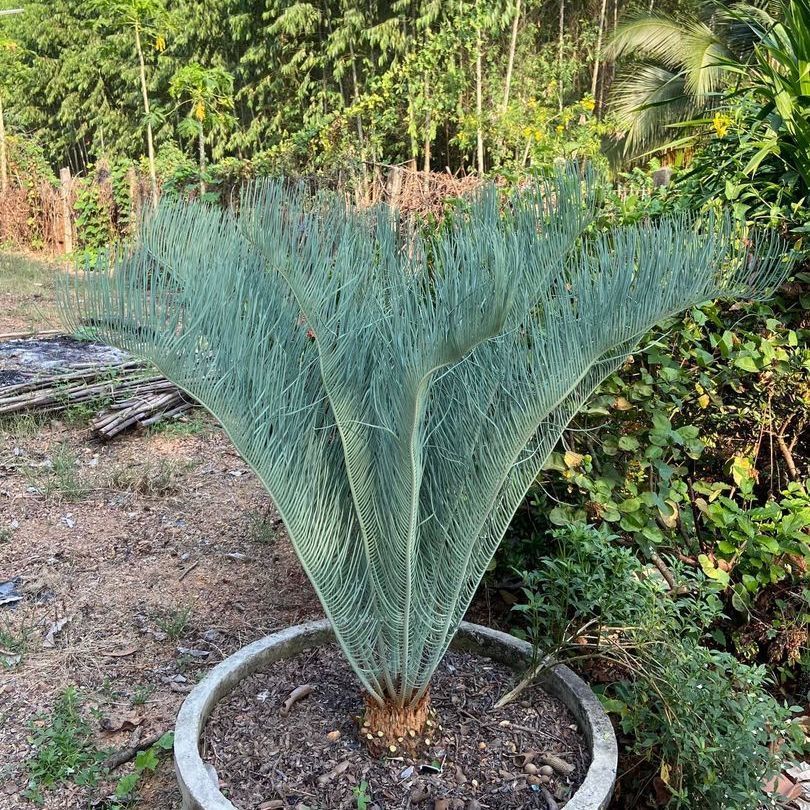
top-left (55, 175), bottom-right (780, 750)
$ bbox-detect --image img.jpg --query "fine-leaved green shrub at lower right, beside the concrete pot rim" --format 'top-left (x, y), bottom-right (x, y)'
top-left (515, 527), bottom-right (792, 810)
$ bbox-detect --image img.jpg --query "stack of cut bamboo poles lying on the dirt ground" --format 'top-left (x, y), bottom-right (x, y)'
top-left (0, 361), bottom-right (194, 439)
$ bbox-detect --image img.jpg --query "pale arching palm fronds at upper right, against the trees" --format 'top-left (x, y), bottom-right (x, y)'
top-left (606, 2), bottom-right (774, 157)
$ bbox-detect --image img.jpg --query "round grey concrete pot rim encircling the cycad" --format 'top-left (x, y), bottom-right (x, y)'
top-left (174, 620), bottom-right (618, 810)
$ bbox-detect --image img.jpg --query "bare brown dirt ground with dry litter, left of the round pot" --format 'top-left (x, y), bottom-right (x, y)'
top-left (0, 257), bottom-right (320, 810)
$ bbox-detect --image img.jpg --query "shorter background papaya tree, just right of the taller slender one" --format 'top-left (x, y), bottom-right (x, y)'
top-left (169, 62), bottom-right (234, 194)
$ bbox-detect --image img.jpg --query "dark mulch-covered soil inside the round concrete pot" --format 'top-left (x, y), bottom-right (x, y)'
top-left (202, 645), bottom-right (589, 810)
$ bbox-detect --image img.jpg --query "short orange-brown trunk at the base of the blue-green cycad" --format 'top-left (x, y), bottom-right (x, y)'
top-left (360, 692), bottom-right (432, 757)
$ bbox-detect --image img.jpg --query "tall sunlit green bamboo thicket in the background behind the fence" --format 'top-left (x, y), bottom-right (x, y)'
top-left (4, 0), bottom-right (620, 176)
